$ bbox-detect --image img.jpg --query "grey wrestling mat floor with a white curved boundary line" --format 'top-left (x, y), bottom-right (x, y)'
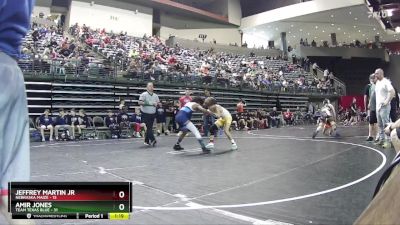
top-left (0, 127), bottom-right (394, 224)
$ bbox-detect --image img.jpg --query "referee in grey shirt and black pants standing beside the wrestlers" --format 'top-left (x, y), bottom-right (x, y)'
top-left (139, 82), bottom-right (160, 147)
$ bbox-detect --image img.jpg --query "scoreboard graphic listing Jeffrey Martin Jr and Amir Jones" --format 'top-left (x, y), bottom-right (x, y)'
top-left (8, 182), bottom-right (132, 220)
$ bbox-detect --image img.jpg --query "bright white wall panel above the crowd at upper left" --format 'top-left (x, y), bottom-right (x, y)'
top-left (69, 0), bottom-right (153, 36)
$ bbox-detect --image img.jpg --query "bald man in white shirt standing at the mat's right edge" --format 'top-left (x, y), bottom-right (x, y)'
top-left (375, 69), bottom-right (395, 148)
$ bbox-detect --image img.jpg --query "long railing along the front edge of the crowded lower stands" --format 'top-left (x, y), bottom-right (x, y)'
top-left (18, 59), bottom-right (345, 96)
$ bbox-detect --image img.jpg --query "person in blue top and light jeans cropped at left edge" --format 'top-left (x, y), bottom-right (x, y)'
top-left (0, 0), bottom-right (35, 224)
